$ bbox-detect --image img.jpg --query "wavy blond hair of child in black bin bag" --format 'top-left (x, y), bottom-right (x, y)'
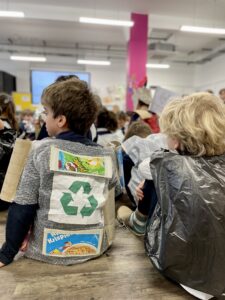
top-left (159, 93), bottom-right (225, 156)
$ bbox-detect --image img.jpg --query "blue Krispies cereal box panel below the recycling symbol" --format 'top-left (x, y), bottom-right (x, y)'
top-left (43, 229), bottom-right (102, 257)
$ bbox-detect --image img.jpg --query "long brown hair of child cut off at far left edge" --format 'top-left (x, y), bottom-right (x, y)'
top-left (0, 93), bottom-right (18, 130)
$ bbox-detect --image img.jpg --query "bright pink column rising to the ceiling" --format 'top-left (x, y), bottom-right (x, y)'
top-left (126, 13), bottom-right (148, 110)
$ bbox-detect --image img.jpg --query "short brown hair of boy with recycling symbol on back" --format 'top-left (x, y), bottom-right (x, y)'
top-left (41, 78), bottom-right (97, 134)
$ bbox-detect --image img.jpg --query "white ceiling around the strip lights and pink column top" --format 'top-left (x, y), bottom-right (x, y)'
top-left (0, 0), bottom-right (225, 64)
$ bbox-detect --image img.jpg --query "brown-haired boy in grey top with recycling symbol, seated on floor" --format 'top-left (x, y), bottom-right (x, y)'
top-left (0, 79), bottom-right (117, 266)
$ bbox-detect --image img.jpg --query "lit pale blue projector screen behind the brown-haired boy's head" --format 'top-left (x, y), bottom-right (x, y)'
top-left (31, 70), bottom-right (90, 104)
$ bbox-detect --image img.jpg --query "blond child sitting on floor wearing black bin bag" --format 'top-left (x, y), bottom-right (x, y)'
top-left (118, 93), bottom-right (225, 299)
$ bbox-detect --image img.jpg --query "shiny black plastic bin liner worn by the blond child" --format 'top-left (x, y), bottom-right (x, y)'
top-left (145, 151), bottom-right (225, 296)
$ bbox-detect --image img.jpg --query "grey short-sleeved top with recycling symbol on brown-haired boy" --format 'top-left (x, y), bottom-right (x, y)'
top-left (15, 134), bottom-right (116, 264)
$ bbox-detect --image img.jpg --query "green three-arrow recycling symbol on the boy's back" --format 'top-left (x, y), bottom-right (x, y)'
top-left (60, 181), bottom-right (98, 217)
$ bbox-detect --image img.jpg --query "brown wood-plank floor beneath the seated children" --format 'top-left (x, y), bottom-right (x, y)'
top-left (0, 212), bottom-right (194, 300)
